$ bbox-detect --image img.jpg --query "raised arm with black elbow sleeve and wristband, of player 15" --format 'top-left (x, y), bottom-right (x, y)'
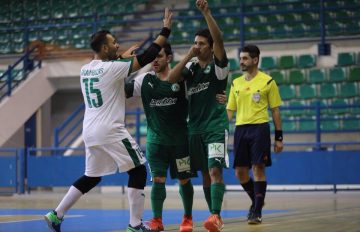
top-left (131, 8), bottom-right (172, 72)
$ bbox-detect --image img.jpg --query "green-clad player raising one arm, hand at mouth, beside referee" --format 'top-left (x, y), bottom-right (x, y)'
top-left (169, 0), bottom-right (229, 232)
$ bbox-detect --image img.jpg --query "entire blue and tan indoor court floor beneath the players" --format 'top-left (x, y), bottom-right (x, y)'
top-left (0, 187), bottom-right (360, 232)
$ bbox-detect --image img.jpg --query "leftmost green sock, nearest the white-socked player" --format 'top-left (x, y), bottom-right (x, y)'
top-left (151, 182), bottom-right (166, 218)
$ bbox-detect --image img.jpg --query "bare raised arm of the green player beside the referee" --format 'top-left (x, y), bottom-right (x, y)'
top-left (196, 0), bottom-right (226, 61)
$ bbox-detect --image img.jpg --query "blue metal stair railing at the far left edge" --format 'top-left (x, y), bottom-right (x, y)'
top-left (0, 46), bottom-right (41, 101)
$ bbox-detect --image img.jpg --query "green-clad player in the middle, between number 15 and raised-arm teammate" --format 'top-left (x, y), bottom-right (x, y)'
top-left (125, 43), bottom-right (196, 232)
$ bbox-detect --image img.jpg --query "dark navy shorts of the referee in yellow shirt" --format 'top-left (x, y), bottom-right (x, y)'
top-left (233, 123), bottom-right (271, 168)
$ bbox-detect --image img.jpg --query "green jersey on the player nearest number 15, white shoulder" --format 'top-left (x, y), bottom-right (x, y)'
top-left (125, 72), bottom-right (188, 145)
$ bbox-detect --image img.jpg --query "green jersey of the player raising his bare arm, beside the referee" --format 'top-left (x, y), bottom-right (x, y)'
top-left (182, 58), bottom-right (229, 134)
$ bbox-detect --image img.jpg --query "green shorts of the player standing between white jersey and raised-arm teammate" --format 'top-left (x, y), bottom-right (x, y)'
top-left (146, 143), bottom-right (197, 180)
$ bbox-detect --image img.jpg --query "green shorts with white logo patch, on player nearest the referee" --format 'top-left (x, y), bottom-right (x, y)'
top-left (189, 130), bottom-right (229, 171)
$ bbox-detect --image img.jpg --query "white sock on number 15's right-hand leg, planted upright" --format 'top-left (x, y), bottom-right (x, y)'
top-left (128, 188), bottom-right (145, 226)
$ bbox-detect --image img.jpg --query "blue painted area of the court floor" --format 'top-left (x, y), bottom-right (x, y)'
top-left (0, 209), bottom-right (287, 232)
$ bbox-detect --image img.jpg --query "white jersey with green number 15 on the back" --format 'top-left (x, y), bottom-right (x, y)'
top-left (80, 60), bottom-right (132, 147)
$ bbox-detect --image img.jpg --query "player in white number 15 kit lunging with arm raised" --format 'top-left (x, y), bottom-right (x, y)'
top-left (45, 9), bottom-right (172, 232)
